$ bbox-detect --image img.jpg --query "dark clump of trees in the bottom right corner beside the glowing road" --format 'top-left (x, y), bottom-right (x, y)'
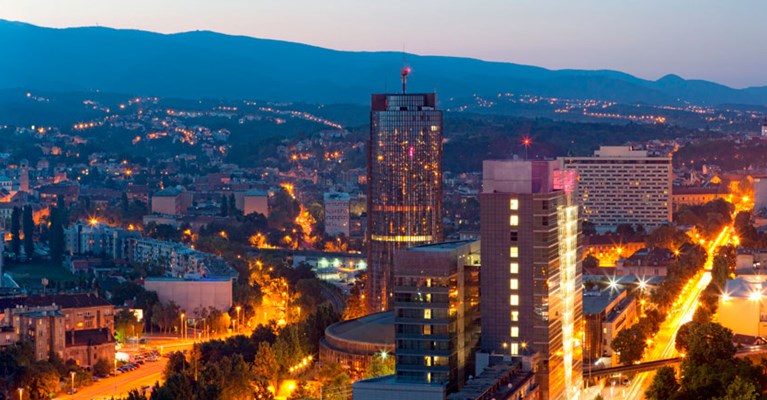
top-left (645, 321), bottom-right (767, 400)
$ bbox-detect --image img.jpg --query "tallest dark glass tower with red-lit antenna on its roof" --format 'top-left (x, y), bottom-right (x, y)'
top-left (367, 74), bottom-right (442, 312)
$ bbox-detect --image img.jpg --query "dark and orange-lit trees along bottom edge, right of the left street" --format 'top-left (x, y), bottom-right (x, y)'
top-left (129, 306), bottom-right (348, 400)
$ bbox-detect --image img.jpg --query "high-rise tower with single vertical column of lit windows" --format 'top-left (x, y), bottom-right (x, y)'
top-left (480, 161), bottom-right (583, 400)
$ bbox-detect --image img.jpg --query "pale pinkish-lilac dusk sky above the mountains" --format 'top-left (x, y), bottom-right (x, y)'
top-left (0, 0), bottom-right (767, 88)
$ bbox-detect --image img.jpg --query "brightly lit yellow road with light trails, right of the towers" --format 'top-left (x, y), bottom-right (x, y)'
top-left (602, 226), bottom-right (732, 400)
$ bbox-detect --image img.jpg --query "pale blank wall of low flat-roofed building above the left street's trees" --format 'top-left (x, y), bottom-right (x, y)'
top-left (144, 278), bottom-right (232, 315)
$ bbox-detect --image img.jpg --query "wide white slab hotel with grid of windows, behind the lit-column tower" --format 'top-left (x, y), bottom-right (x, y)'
top-left (560, 146), bottom-right (672, 229)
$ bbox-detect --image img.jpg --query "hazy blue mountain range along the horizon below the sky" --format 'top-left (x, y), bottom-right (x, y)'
top-left (0, 20), bottom-right (767, 105)
